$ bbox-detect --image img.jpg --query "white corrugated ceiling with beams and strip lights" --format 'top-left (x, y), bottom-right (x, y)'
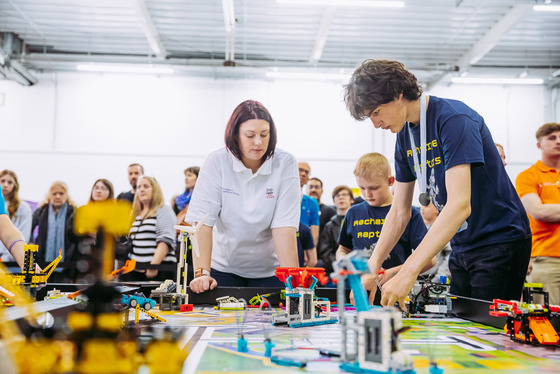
top-left (0, 0), bottom-right (560, 85)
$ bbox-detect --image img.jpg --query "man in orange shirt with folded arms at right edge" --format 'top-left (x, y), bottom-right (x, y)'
top-left (515, 123), bottom-right (560, 305)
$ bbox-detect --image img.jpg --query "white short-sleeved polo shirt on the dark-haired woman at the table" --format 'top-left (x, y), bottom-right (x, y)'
top-left (185, 148), bottom-right (301, 278)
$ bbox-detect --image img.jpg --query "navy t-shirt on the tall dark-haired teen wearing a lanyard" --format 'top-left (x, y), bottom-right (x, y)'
top-left (395, 96), bottom-right (531, 252)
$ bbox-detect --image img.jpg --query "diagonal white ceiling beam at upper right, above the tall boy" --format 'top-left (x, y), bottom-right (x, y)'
top-left (457, 4), bottom-right (533, 71)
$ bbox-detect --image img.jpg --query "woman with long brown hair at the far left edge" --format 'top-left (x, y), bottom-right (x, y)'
top-left (0, 169), bottom-right (31, 262)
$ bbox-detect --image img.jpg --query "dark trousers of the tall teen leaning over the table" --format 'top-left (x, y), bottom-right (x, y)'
top-left (449, 238), bottom-right (531, 301)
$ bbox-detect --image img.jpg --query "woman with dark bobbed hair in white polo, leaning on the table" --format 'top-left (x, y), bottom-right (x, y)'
top-left (185, 100), bottom-right (300, 293)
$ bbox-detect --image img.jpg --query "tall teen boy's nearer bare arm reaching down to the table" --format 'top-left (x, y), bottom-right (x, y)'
top-left (376, 164), bottom-right (471, 306)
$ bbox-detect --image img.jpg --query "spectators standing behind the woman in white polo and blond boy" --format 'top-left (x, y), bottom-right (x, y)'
top-left (0, 153), bottom-right (452, 281)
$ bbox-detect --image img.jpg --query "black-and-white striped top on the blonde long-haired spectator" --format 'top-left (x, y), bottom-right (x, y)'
top-left (129, 206), bottom-right (177, 263)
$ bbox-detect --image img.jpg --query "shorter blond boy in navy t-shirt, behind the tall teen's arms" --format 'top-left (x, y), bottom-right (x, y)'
top-left (336, 153), bottom-right (432, 305)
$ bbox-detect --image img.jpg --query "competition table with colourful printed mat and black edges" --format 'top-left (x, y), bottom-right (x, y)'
top-left (15, 282), bottom-right (560, 374)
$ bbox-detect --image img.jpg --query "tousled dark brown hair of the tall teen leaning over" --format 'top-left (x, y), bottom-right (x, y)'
top-left (344, 59), bottom-right (422, 121)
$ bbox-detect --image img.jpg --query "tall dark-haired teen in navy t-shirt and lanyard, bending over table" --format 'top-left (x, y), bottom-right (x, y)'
top-left (345, 60), bottom-right (531, 305)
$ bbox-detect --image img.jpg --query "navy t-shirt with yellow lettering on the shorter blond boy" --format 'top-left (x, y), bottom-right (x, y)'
top-left (338, 201), bottom-right (427, 269)
